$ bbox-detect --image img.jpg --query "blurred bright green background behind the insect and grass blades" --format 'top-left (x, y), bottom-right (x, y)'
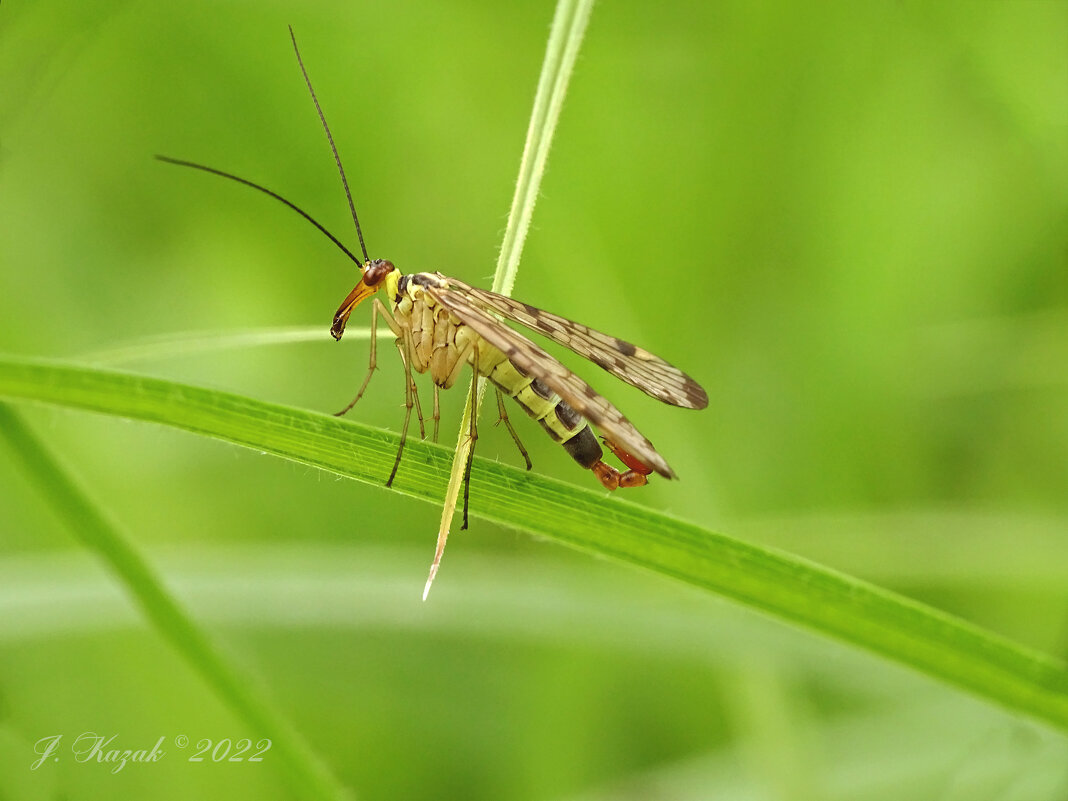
top-left (0, 0), bottom-right (1068, 801)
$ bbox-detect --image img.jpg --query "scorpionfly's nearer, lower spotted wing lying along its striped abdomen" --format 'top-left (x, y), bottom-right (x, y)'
top-left (424, 283), bottom-right (675, 478)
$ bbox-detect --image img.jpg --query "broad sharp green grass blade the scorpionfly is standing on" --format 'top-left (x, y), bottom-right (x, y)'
top-left (0, 357), bottom-right (1068, 731)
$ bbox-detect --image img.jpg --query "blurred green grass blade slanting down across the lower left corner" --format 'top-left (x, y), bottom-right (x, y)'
top-left (0, 404), bottom-right (350, 801)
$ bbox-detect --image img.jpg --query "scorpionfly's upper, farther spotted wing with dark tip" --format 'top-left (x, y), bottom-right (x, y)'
top-left (446, 278), bottom-right (708, 409)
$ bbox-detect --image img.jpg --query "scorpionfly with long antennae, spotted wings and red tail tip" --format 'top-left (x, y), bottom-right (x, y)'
top-left (156, 28), bottom-right (708, 529)
